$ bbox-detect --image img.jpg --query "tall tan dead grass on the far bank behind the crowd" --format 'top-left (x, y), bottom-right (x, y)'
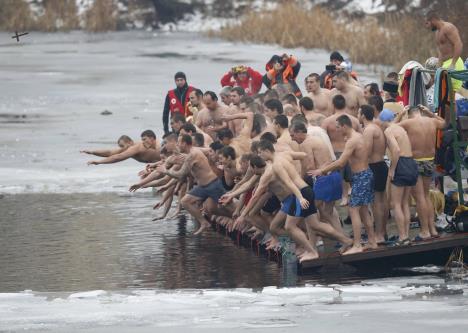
top-left (217, 2), bottom-right (436, 68)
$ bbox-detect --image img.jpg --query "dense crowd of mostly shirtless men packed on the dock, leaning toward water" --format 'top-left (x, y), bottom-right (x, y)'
top-left (83, 11), bottom-right (464, 261)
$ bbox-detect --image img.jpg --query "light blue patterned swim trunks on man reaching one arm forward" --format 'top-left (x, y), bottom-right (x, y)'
top-left (349, 169), bottom-right (374, 207)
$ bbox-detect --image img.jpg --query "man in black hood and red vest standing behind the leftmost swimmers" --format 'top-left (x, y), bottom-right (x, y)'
top-left (163, 72), bottom-right (195, 133)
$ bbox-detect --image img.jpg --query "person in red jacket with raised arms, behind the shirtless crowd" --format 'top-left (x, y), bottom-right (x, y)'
top-left (221, 65), bottom-right (262, 96)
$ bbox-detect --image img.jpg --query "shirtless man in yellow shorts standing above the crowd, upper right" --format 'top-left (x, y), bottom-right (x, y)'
top-left (426, 10), bottom-right (465, 91)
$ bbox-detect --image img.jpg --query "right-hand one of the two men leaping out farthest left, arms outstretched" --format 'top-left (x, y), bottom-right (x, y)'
top-left (88, 130), bottom-right (161, 165)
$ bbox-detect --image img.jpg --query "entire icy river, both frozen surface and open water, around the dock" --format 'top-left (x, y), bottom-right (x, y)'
top-left (0, 32), bottom-right (468, 332)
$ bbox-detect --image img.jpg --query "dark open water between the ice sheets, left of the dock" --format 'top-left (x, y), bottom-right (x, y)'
top-left (0, 193), bottom-right (281, 292)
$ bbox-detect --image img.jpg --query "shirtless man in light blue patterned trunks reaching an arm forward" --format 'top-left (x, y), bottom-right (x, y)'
top-left (310, 115), bottom-right (377, 254)
